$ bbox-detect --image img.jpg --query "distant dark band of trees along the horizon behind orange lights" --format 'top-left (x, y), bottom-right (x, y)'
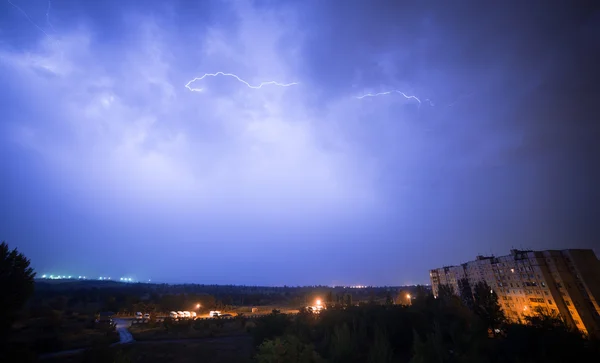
top-left (29, 281), bottom-right (418, 316)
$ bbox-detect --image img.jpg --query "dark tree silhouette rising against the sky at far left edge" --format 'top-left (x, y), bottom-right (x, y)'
top-left (0, 242), bottom-right (35, 344)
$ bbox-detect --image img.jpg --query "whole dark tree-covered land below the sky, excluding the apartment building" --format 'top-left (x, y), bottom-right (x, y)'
top-left (0, 243), bottom-right (600, 363)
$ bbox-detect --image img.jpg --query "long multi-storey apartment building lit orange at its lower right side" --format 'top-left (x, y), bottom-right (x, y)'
top-left (429, 249), bottom-right (600, 336)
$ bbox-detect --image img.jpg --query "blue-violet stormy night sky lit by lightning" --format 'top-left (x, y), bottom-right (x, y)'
top-left (0, 0), bottom-right (600, 285)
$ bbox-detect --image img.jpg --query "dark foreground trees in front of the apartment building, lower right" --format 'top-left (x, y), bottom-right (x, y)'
top-left (251, 285), bottom-right (600, 363)
